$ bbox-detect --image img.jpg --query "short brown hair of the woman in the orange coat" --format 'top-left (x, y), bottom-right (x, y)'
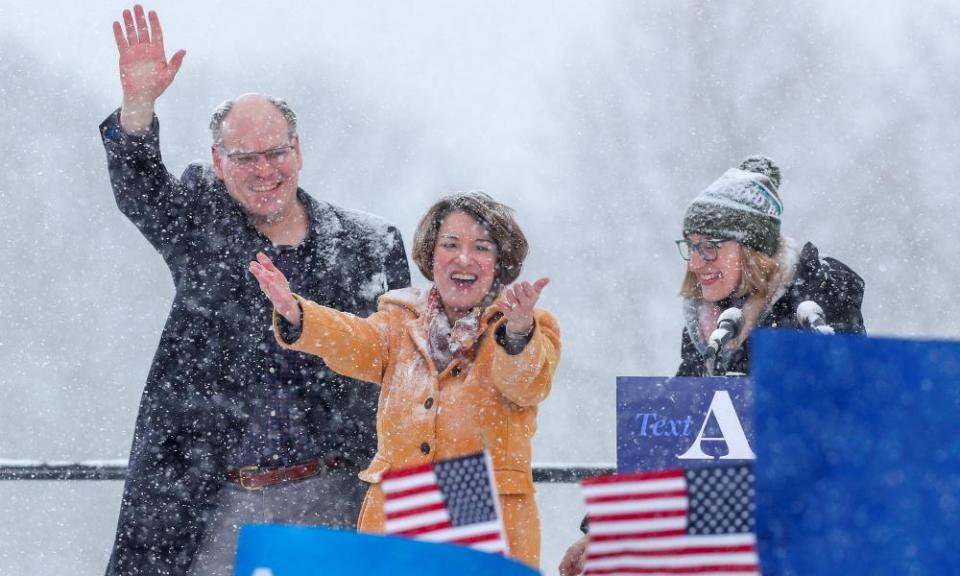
top-left (413, 192), bottom-right (529, 286)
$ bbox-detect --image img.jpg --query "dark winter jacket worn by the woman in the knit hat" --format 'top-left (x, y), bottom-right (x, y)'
top-left (677, 240), bottom-right (866, 376)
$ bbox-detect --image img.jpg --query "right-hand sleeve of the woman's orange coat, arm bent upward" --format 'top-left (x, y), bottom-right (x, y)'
top-left (490, 310), bottom-right (560, 406)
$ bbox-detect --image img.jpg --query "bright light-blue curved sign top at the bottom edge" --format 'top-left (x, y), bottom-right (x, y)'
top-left (235, 524), bottom-right (538, 576)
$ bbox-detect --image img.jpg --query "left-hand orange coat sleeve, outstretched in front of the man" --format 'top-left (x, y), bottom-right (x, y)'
top-left (273, 295), bottom-right (390, 384)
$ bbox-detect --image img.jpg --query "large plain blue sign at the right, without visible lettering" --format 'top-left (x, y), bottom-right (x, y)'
top-left (751, 331), bottom-right (960, 576)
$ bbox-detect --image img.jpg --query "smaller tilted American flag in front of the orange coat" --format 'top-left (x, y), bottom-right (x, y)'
top-left (380, 452), bottom-right (507, 554)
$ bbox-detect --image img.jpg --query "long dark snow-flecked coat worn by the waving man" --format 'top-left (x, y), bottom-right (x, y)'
top-left (100, 111), bottom-right (410, 575)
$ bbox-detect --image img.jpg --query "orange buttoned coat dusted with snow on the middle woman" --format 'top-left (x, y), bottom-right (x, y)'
top-left (275, 288), bottom-right (560, 567)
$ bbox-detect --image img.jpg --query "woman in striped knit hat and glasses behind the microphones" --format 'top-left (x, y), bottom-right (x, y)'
top-left (677, 156), bottom-right (865, 376)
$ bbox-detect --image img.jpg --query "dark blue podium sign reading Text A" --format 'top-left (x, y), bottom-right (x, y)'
top-left (617, 377), bottom-right (754, 474)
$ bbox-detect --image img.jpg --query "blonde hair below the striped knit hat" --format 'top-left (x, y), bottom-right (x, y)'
top-left (680, 239), bottom-right (784, 346)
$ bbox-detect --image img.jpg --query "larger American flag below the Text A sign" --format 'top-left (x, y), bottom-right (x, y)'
top-left (581, 465), bottom-right (760, 576)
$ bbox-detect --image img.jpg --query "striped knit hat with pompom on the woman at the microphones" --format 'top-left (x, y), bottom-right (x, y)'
top-left (683, 156), bottom-right (783, 256)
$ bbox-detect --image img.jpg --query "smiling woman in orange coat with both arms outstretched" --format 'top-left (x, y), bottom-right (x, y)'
top-left (250, 192), bottom-right (560, 567)
